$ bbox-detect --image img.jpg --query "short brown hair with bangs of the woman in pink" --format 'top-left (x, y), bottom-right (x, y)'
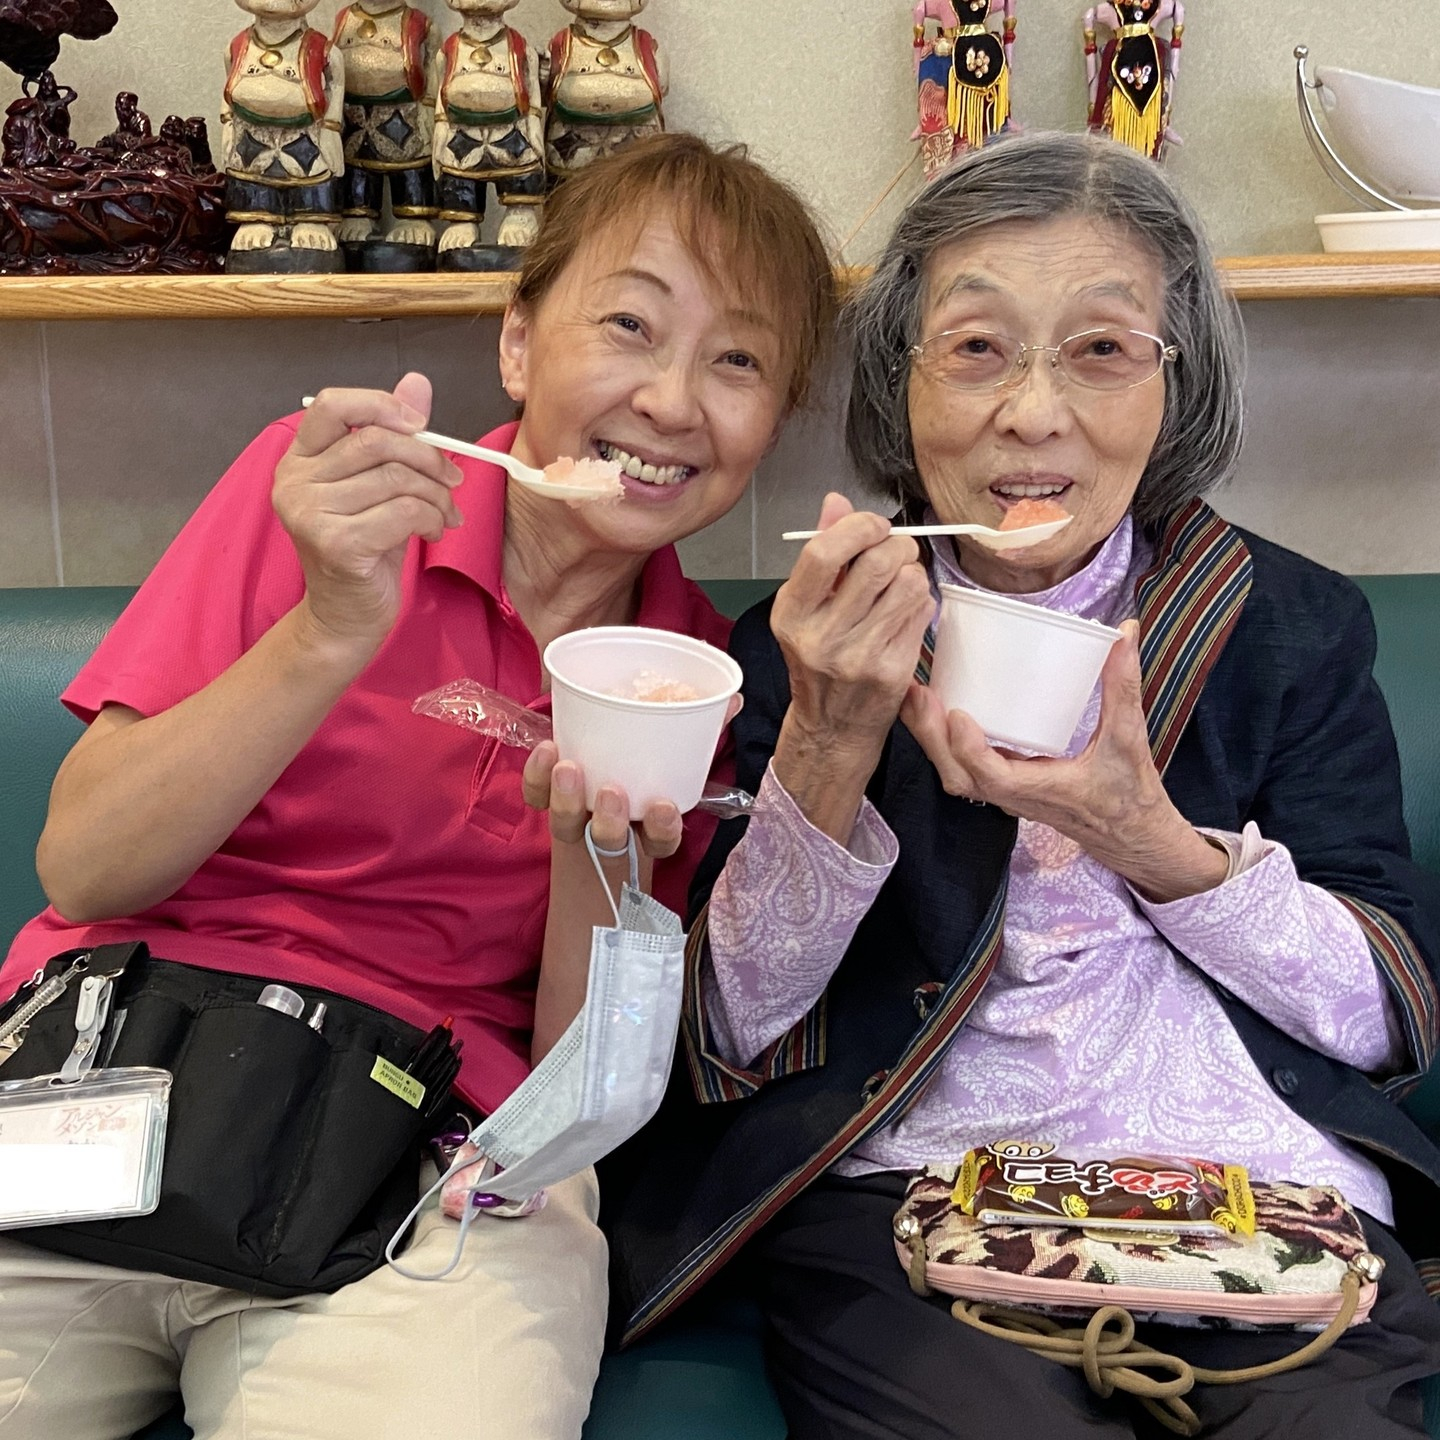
top-left (516, 134), bottom-right (837, 406)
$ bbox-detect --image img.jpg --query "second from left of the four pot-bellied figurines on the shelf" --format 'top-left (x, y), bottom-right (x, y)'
top-left (333, 0), bottom-right (439, 271)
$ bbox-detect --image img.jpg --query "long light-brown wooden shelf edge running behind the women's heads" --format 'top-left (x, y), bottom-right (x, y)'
top-left (0, 251), bottom-right (1440, 321)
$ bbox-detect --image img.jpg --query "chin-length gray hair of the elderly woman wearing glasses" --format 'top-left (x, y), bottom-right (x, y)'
top-left (845, 134), bottom-right (1244, 527)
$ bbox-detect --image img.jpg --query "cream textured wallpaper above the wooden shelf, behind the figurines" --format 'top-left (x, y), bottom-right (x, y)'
top-left (14, 0), bottom-right (1440, 261)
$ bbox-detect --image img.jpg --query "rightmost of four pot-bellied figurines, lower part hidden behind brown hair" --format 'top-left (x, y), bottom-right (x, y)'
top-left (540, 0), bottom-right (668, 180)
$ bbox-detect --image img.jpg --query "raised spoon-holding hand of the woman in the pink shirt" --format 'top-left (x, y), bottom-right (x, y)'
top-left (271, 374), bottom-right (462, 647)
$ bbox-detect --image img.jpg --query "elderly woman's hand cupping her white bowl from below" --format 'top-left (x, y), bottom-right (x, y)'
top-left (901, 621), bottom-right (1228, 901)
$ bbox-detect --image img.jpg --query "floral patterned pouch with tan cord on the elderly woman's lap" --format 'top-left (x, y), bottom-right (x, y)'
top-left (893, 1148), bottom-right (1384, 1436)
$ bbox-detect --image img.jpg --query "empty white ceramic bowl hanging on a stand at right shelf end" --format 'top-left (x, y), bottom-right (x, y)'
top-left (1315, 66), bottom-right (1440, 203)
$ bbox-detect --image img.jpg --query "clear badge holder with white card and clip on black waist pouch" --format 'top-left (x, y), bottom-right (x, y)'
top-left (0, 946), bottom-right (170, 1230)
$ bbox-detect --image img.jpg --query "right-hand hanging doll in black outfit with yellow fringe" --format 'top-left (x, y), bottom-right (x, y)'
top-left (1084, 0), bottom-right (1185, 160)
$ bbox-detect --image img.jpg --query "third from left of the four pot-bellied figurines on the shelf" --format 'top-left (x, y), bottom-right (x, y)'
top-left (431, 0), bottom-right (546, 269)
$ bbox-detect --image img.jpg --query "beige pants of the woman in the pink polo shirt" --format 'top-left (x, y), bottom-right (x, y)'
top-left (0, 1172), bottom-right (606, 1440)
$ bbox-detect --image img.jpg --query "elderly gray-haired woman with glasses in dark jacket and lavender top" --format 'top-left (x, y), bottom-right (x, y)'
top-left (602, 135), bottom-right (1440, 1440)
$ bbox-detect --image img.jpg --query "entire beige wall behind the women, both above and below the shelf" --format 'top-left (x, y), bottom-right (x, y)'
top-left (0, 0), bottom-right (1440, 585)
